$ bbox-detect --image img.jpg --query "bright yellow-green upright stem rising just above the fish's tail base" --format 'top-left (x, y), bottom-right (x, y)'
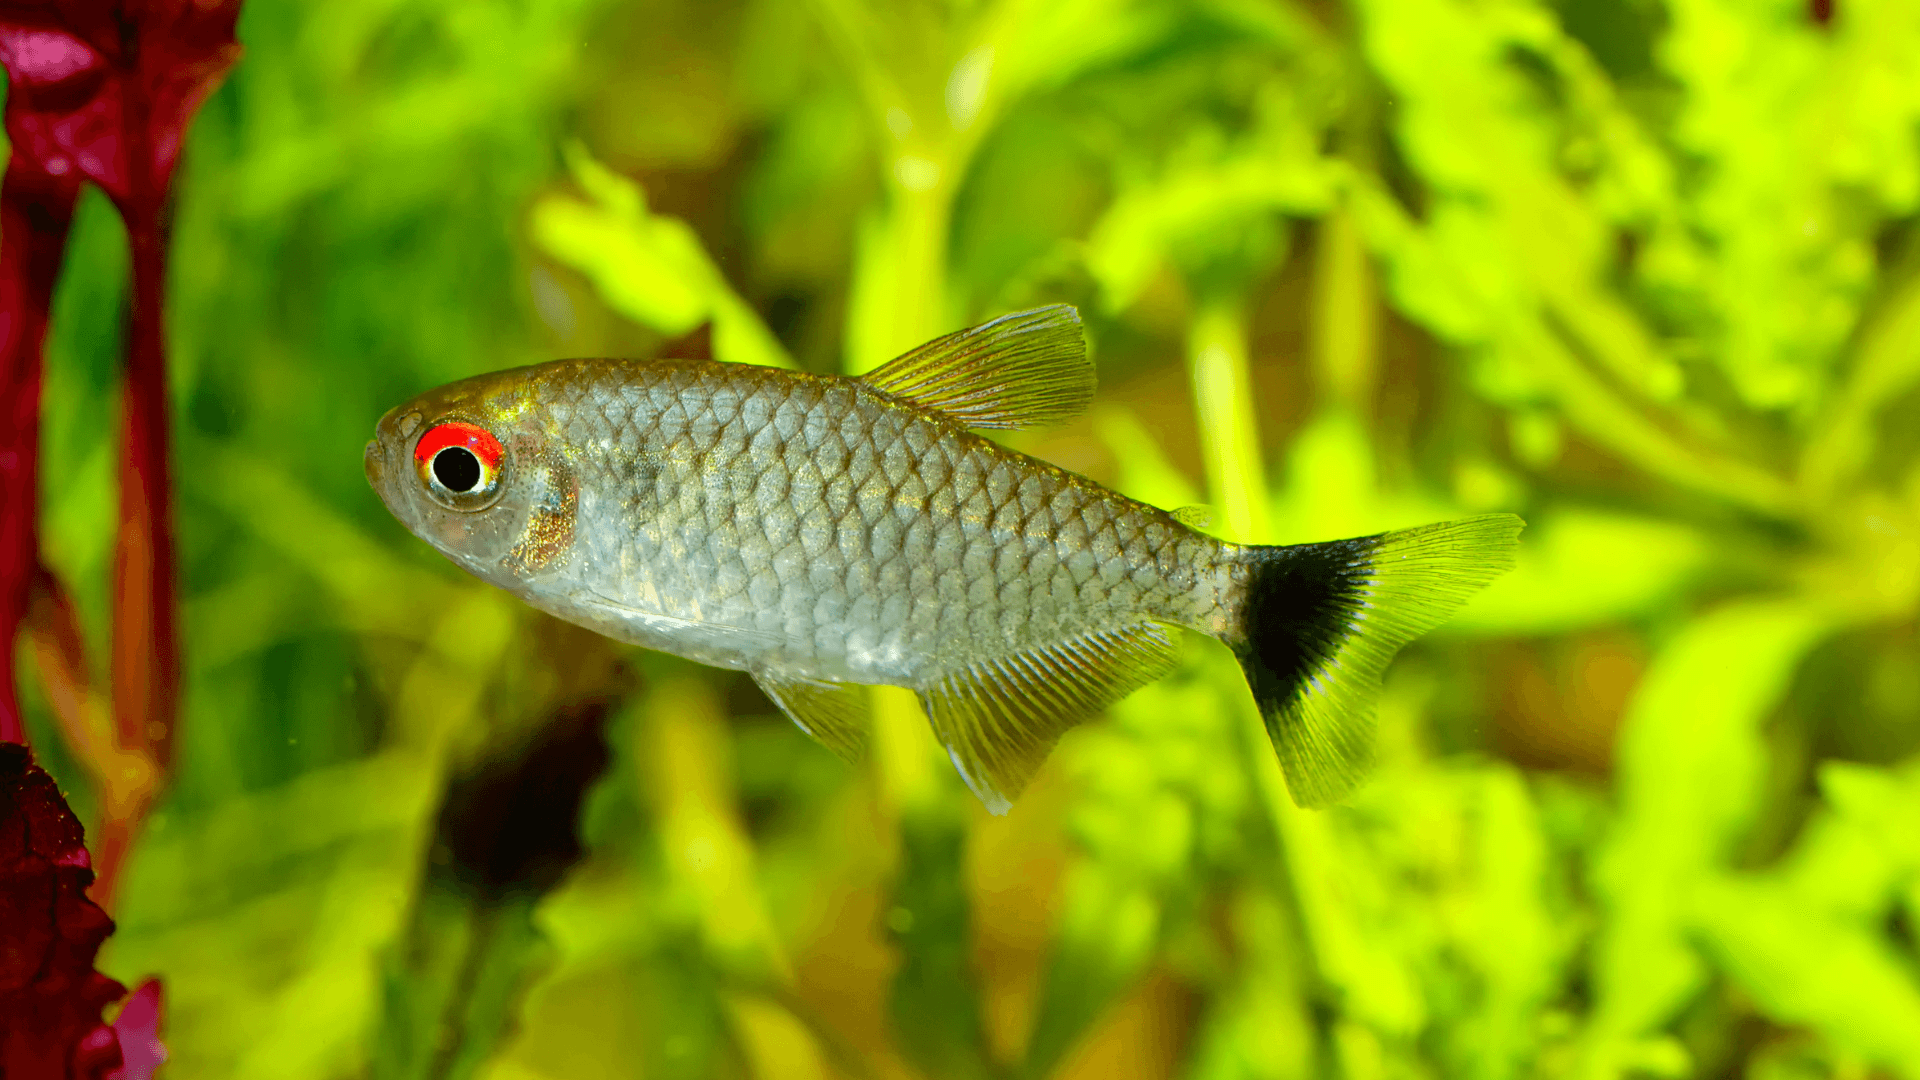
top-left (1187, 298), bottom-right (1269, 544)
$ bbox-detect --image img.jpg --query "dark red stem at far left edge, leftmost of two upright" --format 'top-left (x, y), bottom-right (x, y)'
top-left (0, 166), bottom-right (79, 742)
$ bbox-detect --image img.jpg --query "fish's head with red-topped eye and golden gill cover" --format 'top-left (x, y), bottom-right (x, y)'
top-left (367, 369), bottom-right (578, 588)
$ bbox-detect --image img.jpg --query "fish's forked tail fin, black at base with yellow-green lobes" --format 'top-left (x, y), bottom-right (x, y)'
top-left (1227, 513), bottom-right (1524, 807)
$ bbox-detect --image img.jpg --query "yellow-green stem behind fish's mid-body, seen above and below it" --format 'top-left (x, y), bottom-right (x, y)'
top-left (812, 21), bottom-right (996, 1060)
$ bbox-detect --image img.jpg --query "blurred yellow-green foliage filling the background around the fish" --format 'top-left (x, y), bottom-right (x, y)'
top-left (27, 0), bottom-right (1920, 1080)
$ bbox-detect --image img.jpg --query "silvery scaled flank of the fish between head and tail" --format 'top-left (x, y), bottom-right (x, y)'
top-left (524, 361), bottom-right (1221, 684)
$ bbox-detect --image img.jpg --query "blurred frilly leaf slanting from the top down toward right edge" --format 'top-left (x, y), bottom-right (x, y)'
top-left (1350, 0), bottom-right (1791, 513)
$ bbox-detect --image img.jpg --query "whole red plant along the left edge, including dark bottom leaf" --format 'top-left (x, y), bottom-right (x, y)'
top-left (0, 0), bottom-right (240, 1078)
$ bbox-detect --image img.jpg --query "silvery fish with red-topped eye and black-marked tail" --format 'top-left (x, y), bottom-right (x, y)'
top-left (365, 304), bottom-right (1523, 813)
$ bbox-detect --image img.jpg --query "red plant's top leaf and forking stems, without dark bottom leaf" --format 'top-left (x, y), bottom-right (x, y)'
top-left (0, 0), bottom-right (240, 899)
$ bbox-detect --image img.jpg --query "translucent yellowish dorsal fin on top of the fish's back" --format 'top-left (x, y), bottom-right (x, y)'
top-left (862, 304), bottom-right (1092, 429)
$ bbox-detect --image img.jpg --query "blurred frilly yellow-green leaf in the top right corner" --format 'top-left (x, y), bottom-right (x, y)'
top-left (1659, 0), bottom-right (1920, 407)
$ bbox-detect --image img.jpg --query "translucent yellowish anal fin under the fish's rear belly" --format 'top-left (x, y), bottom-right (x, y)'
top-left (920, 623), bottom-right (1179, 813)
